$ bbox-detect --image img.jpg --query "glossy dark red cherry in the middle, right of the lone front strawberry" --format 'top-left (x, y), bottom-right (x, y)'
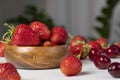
top-left (94, 55), bottom-right (111, 69)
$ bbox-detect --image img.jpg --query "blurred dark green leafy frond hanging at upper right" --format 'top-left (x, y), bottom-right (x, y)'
top-left (94, 0), bottom-right (119, 39)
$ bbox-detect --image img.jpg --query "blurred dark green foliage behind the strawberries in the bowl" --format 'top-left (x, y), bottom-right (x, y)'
top-left (5, 5), bottom-right (55, 29)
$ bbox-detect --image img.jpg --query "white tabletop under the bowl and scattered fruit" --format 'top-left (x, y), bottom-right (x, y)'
top-left (0, 58), bottom-right (120, 80)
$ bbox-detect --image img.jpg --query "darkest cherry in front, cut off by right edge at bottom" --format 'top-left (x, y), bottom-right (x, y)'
top-left (108, 62), bottom-right (120, 78)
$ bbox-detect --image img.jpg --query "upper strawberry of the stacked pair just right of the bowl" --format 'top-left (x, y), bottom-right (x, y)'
top-left (70, 35), bottom-right (86, 47)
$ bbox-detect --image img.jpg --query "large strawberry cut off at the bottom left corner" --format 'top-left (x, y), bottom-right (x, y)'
top-left (0, 63), bottom-right (21, 80)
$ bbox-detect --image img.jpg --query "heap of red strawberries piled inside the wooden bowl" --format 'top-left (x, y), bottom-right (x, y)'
top-left (4, 21), bottom-right (68, 46)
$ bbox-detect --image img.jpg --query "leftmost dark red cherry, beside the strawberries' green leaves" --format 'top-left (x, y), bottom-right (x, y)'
top-left (88, 48), bottom-right (101, 61)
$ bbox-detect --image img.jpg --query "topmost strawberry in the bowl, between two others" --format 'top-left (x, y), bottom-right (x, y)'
top-left (30, 21), bottom-right (51, 41)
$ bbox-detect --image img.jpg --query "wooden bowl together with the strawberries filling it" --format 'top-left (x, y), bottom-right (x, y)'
top-left (4, 21), bottom-right (68, 69)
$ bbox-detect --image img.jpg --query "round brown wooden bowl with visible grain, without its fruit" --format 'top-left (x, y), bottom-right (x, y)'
top-left (5, 45), bottom-right (68, 69)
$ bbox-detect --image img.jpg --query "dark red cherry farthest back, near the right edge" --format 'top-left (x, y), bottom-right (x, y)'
top-left (104, 45), bottom-right (120, 58)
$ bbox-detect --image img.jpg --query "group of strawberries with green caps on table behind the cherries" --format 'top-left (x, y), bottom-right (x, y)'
top-left (69, 35), bottom-right (108, 60)
